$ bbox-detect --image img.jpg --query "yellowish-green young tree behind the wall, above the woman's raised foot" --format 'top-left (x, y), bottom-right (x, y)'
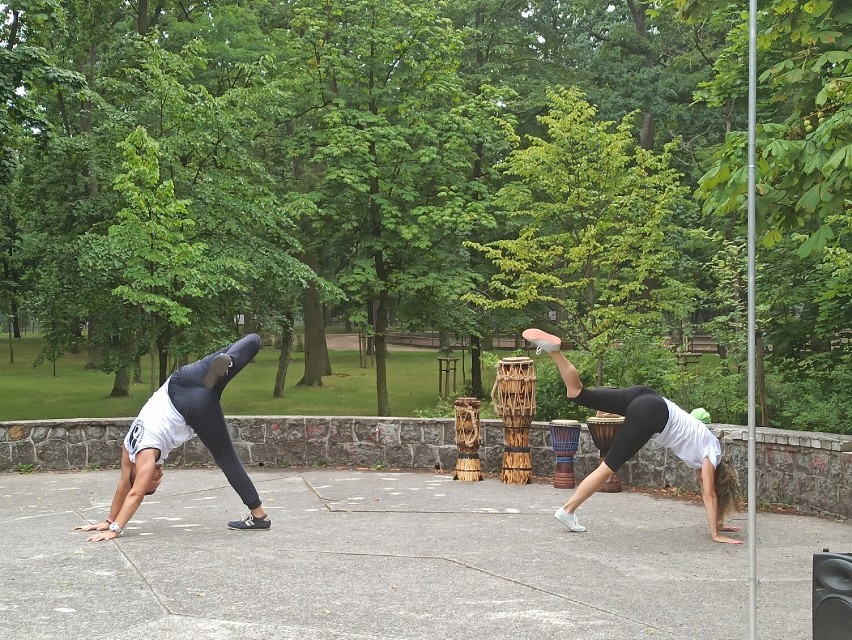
top-left (471, 89), bottom-right (697, 381)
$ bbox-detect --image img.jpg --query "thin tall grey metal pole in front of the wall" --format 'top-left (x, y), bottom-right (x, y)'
top-left (748, 0), bottom-right (757, 640)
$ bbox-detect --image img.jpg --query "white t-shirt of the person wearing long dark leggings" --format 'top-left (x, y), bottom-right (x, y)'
top-left (124, 380), bottom-right (195, 464)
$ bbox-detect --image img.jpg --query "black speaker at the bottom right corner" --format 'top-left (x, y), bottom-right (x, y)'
top-left (813, 549), bottom-right (852, 640)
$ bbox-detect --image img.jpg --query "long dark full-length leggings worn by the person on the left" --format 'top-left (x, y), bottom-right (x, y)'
top-left (169, 333), bottom-right (261, 509)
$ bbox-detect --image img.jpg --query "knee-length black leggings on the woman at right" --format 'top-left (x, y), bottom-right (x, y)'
top-left (571, 385), bottom-right (669, 471)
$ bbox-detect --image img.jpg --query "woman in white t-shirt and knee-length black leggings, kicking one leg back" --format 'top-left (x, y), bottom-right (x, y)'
top-left (523, 329), bottom-right (742, 544)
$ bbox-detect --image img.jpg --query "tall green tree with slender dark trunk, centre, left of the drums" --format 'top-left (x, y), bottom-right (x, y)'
top-left (276, 0), bottom-right (510, 415)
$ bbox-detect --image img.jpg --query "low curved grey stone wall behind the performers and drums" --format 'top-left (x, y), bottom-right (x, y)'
top-left (0, 416), bottom-right (852, 518)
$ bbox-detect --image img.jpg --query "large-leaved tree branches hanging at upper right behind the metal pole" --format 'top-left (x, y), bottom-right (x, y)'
top-left (689, 0), bottom-right (852, 256)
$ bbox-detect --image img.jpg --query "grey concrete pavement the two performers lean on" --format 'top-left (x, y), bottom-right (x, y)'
top-left (0, 467), bottom-right (852, 640)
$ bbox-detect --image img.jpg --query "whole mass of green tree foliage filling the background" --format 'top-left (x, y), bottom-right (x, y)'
top-left (0, 0), bottom-right (852, 426)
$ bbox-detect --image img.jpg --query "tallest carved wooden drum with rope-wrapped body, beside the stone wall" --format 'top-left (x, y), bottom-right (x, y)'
top-left (491, 357), bottom-right (535, 484)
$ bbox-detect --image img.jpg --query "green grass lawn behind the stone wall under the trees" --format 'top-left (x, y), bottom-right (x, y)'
top-left (0, 337), bottom-right (482, 421)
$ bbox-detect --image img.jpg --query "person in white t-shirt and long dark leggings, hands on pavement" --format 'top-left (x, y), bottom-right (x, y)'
top-left (82, 333), bottom-right (272, 542)
